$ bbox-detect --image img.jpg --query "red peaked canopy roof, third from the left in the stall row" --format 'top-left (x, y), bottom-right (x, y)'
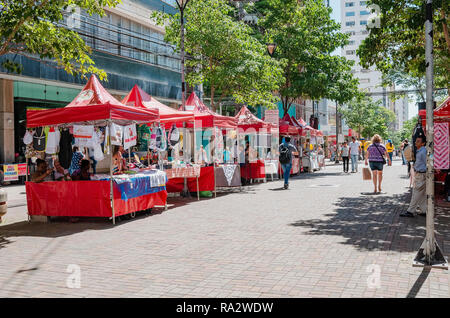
top-left (186, 92), bottom-right (237, 128)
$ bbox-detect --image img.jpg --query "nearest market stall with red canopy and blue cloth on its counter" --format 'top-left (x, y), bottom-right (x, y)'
top-left (26, 75), bottom-right (167, 223)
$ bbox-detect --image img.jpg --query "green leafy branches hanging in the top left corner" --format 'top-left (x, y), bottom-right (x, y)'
top-left (0, 0), bottom-right (120, 79)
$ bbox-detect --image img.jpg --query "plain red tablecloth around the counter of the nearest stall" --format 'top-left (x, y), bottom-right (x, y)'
top-left (25, 181), bottom-right (167, 217)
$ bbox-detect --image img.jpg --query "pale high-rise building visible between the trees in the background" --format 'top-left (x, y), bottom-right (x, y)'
top-left (341, 0), bottom-right (389, 102)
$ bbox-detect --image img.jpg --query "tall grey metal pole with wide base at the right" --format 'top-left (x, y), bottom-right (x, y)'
top-left (413, 0), bottom-right (448, 269)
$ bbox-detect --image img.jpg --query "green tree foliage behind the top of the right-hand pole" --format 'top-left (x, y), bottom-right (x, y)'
top-left (357, 0), bottom-right (450, 89)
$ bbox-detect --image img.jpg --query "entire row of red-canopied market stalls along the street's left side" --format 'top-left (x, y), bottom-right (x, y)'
top-left (24, 76), bottom-right (323, 222)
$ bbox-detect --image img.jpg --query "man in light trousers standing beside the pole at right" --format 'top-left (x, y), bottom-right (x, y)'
top-left (400, 136), bottom-right (427, 217)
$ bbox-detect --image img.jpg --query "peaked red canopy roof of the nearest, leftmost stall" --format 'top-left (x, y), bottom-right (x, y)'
top-left (27, 75), bottom-right (159, 127)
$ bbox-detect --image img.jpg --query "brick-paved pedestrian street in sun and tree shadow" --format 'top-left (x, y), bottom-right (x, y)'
top-left (0, 161), bottom-right (450, 298)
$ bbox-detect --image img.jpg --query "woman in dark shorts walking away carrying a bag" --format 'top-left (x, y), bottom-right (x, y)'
top-left (365, 134), bottom-right (391, 194)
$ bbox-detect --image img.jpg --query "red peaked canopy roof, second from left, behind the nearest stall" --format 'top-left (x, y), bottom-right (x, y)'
top-left (122, 85), bottom-right (194, 125)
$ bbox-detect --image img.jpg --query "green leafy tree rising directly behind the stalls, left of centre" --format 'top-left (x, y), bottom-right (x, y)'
top-left (152, 0), bottom-right (283, 110)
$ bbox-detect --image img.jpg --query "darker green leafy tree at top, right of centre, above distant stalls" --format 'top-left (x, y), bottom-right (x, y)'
top-left (255, 0), bottom-right (356, 112)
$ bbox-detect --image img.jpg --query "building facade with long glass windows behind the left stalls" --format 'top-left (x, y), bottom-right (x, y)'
top-left (0, 0), bottom-right (181, 163)
